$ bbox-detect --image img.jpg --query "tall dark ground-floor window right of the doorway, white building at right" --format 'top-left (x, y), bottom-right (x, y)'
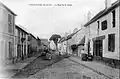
top-left (108, 34), bottom-right (115, 52)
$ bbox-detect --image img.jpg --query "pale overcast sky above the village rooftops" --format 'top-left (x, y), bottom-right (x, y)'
top-left (0, 0), bottom-right (116, 39)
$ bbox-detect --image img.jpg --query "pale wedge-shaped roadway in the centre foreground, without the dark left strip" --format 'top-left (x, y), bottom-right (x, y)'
top-left (28, 59), bottom-right (109, 79)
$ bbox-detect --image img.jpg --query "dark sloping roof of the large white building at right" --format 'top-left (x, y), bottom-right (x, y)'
top-left (84, 0), bottom-right (120, 27)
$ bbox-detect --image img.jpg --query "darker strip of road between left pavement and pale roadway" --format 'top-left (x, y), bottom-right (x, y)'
top-left (12, 56), bottom-right (62, 78)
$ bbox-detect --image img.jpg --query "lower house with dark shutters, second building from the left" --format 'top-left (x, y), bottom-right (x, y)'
top-left (15, 25), bottom-right (29, 62)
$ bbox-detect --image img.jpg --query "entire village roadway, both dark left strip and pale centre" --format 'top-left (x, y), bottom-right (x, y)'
top-left (12, 52), bottom-right (118, 79)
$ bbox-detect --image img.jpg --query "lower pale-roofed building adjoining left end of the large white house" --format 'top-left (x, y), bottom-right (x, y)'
top-left (67, 28), bottom-right (85, 56)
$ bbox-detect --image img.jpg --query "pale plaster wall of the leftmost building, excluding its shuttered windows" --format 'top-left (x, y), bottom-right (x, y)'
top-left (0, 4), bottom-right (15, 64)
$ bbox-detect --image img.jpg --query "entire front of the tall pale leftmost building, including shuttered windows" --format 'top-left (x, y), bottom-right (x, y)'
top-left (0, 3), bottom-right (16, 63)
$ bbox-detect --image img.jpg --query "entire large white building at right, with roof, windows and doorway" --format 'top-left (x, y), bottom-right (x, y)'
top-left (85, 0), bottom-right (120, 65)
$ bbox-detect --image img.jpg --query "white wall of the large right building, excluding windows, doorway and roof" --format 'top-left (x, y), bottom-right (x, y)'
top-left (87, 5), bottom-right (120, 59)
